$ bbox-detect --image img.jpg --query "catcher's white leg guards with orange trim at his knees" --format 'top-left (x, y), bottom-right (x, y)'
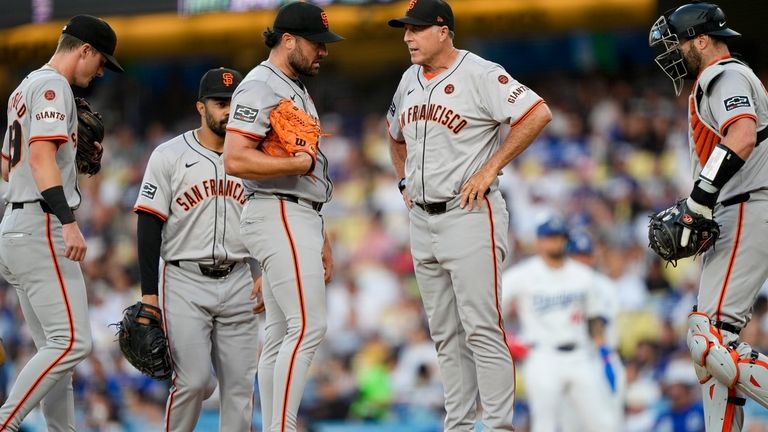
top-left (688, 312), bottom-right (768, 408)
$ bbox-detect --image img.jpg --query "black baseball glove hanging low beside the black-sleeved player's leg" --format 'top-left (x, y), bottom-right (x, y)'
top-left (114, 301), bottom-right (173, 380)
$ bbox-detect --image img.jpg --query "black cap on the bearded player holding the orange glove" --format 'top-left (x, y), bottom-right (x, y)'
top-left (272, 1), bottom-right (344, 43)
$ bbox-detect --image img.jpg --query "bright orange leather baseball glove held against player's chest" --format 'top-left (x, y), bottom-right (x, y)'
top-left (261, 99), bottom-right (322, 174)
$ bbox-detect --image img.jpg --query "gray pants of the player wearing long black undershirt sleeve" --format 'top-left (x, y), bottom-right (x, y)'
top-left (162, 263), bottom-right (258, 432)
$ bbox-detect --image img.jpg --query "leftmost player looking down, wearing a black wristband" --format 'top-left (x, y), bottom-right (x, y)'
top-left (0, 15), bottom-right (123, 431)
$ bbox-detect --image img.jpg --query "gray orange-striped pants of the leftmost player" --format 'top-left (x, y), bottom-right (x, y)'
top-left (0, 204), bottom-right (92, 432)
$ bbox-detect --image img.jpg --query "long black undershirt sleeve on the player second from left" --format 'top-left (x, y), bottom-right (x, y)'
top-left (136, 210), bottom-right (165, 295)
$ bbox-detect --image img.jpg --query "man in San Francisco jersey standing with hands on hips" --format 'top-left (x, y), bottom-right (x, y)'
top-left (387, 0), bottom-right (551, 431)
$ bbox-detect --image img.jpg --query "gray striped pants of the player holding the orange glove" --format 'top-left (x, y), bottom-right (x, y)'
top-left (240, 198), bottom-right (326, 432)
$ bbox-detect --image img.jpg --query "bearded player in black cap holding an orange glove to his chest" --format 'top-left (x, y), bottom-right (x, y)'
top-left (224, 2), bottom-right (343, 432)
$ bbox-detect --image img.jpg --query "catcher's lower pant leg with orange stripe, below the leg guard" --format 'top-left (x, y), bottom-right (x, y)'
top-left (701, 378), bottom-right (744, 432)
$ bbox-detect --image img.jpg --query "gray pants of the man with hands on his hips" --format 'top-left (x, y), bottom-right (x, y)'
top-left (410, 191), bottom-right (515, 431)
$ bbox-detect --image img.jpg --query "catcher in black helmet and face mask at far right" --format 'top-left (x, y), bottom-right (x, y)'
top-left (649, 2), bottom-right (768, 431)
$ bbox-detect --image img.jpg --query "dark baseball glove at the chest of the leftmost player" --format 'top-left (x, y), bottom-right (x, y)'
top-left (75, 97), bottom-right (104, 176)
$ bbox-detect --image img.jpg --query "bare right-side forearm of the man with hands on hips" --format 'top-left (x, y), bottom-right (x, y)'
top-left (483, 104), bottom-right (552, 172)
